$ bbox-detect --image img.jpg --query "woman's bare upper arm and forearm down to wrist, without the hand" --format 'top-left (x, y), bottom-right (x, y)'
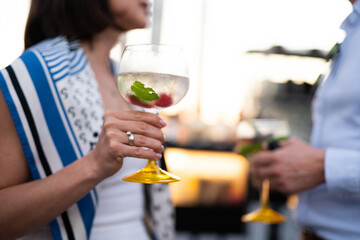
top-left (0, 89), bottom-right (102, 239)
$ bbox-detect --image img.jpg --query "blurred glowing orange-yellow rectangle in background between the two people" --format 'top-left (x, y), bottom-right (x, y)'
top-left (165, 148), bottom-right (249, 206)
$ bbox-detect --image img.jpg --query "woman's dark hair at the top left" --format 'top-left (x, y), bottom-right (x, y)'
top-left (24, 0), bottom-right (115, 49)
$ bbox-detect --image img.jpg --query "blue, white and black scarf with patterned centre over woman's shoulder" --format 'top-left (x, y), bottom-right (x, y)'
top-left (0, 37), bottom-right (103, 240)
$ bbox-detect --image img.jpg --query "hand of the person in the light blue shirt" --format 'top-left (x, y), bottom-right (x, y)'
top-left (249, 138), bottom-right (325, 194)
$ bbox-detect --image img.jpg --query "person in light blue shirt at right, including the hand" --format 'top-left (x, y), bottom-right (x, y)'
top-left (250, 0), bottom-right (360, 240)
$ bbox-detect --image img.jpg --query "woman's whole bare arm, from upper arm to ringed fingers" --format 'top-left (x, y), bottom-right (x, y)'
top-left (0, 91), bottom-right (165, 239)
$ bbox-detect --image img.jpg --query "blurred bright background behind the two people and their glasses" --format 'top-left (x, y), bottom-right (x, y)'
top-left (0, 0), bottom-right (351, 240)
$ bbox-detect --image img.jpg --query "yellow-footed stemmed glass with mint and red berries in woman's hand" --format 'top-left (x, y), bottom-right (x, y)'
top-left (118, 44), bottom-right (189, 183)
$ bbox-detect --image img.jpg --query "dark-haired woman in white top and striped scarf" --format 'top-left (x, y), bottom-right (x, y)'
top-left (0, 0), bottom-right (174, 239)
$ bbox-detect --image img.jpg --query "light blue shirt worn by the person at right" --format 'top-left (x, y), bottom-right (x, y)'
top-left (296, 1), bottom-right (360, 240)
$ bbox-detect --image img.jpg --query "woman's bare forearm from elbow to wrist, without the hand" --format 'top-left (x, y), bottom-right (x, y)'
top-left (0, 158), bottom-right (101, 239)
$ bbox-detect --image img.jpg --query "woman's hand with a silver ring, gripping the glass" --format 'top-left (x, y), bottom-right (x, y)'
top-left (89, 110), bottom-right (166, 178)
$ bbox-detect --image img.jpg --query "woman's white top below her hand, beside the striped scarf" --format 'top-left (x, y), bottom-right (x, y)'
top-left (90, 158), bottom-right (149, 240)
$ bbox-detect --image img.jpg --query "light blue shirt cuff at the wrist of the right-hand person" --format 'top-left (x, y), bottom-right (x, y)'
top-left (325, 148), bottom-right (360, 200)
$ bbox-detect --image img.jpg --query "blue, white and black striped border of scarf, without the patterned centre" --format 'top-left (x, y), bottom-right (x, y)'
top-left (0, 38), bottom-right (97, 240)
